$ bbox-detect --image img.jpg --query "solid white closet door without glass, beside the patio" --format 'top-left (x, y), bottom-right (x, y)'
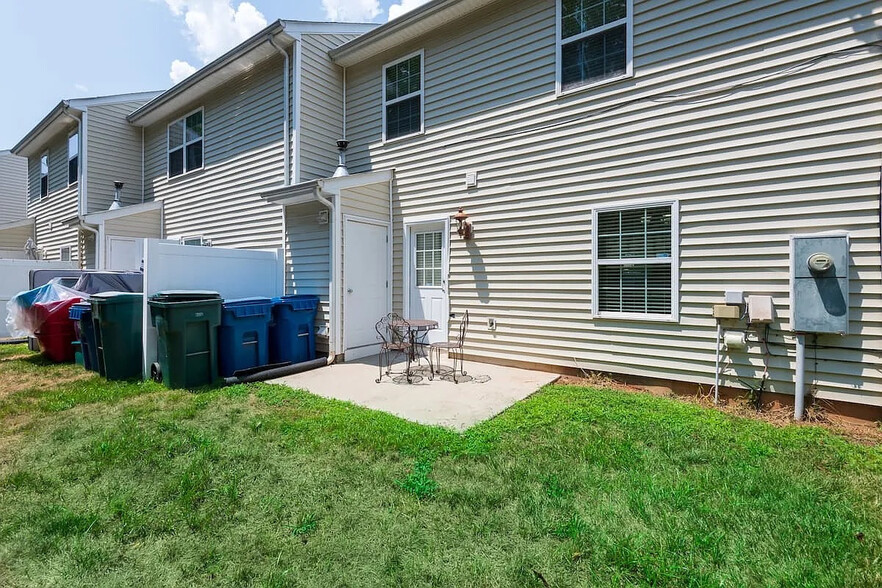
top-left (343, 219), bottom-right (389, 361)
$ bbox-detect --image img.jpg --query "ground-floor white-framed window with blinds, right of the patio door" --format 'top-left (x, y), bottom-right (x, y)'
top-left (591, 201), bottom-right (680, 321)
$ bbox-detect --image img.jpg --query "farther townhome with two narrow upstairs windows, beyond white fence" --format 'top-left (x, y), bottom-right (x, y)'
top-left (8, 92), bottom-right (161, 269)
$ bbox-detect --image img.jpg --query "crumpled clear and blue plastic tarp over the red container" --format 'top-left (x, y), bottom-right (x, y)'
top-left (6, 278), bottom-right (89, 337)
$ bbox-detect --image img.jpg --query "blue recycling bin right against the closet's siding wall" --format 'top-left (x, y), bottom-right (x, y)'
top-left (270, 294), bottom-right (319, 363)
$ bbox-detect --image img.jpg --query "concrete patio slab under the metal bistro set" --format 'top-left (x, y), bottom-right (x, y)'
top-left (273, 357), bottom-right (557, 431)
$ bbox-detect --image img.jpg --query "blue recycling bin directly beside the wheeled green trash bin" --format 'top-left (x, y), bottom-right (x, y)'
top-left (217, 298), bottom-right (273, 378)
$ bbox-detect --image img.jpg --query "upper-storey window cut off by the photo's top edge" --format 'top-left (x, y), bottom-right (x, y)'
top-left (557, 0), bottom-right (634, 93)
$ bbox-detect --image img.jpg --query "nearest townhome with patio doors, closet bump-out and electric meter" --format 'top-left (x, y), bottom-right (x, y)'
top-left (266, 0), bottom-right (882, 418)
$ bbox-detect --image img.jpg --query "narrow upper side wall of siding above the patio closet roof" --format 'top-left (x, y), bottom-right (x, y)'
top-left (300, 34), bottom-right (357, 182)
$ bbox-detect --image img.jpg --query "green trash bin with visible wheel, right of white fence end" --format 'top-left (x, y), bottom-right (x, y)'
top-left (148, 290), bottom-right (222, 388)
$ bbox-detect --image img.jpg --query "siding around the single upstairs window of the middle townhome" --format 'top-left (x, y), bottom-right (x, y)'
top-left (145, 56), bottom-right (284, 249)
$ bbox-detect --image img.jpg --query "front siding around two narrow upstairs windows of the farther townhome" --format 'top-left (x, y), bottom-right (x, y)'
top-left (28, 133), bottom-right (80, 261)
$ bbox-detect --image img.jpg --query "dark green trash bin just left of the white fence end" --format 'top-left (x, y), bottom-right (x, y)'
top-left (89, 292), bottom-right (144, 380)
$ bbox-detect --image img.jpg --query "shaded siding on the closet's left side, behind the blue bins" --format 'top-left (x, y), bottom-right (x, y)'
top-left (285, 202), bottom-right (331, 353)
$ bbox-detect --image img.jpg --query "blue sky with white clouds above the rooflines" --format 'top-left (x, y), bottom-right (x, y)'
top-left (0, 0), bottom-right (427, 149)
